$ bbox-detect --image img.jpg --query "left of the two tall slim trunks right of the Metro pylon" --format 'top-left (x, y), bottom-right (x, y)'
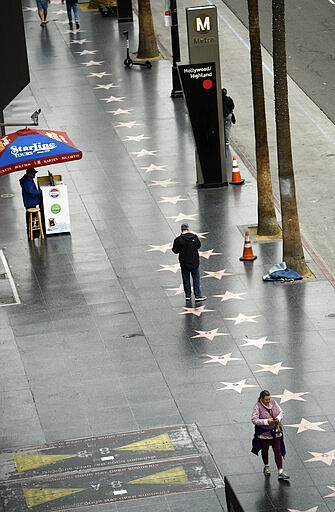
top-left (248, 0), bottom-right (280, 236)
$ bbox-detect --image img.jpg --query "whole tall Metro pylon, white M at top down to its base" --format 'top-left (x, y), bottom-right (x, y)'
top-left (185, 5), bottom-right (228, 187)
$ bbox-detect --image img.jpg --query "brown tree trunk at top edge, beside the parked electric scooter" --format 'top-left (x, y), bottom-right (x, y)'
top-left (137, 0), bottom-right (159, 59)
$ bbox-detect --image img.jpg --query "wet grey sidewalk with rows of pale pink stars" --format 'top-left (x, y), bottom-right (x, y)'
top-left (0, 0), bottom-right (335, 512)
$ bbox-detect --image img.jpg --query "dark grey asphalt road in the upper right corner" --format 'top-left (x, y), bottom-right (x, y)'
top-left (220, 0), bottom-right (335, 123)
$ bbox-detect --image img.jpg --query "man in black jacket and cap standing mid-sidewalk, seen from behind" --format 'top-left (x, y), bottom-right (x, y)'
top-left (172, 224), bottom-right (207, 301)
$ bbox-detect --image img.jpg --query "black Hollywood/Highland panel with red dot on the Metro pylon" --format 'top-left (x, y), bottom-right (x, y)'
top-left (178, 62), bottom-right (228, 187)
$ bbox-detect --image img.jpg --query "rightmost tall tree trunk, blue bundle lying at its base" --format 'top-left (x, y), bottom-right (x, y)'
top-left (272, 0), bottom-right (312, 277)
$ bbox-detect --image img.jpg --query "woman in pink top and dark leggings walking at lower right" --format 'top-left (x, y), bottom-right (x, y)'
top-left (251, 389), bottom-right (290, 480)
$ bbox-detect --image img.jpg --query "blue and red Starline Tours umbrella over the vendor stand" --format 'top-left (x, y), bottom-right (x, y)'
top-left (0, 128), bottom-right (82, 176)
